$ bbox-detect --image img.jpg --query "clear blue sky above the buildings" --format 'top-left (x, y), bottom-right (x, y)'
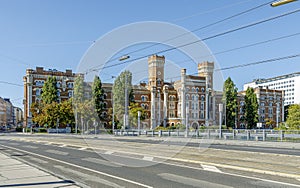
top-left (0, 0), bottom-right (300, 107)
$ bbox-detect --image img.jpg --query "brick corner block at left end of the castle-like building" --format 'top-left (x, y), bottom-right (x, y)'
top-left (23, 67), bottom-right (76, 126)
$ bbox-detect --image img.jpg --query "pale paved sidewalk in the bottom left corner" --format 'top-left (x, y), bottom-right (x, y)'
top-left (0, 151), bottom-right (78, 188)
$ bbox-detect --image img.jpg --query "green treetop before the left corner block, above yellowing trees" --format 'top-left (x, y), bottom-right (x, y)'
top-left (42, 76), bottom-right (58, 104)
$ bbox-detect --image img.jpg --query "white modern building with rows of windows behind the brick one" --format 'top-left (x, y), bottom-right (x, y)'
top-left (244, 72), bottom-right (300, 106)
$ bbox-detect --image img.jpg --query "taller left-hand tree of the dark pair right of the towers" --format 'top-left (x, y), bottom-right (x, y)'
top-left (223, 77), bottom-right (237, 128)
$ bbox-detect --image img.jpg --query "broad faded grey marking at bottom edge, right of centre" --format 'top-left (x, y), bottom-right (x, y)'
top-left (158, 173), bottom-right (233, 188)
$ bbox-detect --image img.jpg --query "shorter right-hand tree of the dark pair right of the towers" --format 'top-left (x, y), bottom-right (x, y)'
top-left (245, 87), bottom-right (258, 129)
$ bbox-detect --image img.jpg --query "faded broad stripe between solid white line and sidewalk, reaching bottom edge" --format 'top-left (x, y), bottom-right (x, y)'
top-left (54, 165), bottom-right (123, 188)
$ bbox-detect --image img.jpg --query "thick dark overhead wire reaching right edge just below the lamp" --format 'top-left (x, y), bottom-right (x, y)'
top-left (86, 9), bottom-right (300, 73)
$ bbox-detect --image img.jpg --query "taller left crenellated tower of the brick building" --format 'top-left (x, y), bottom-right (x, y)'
top-left (148, 55), bottom-right (165, 129)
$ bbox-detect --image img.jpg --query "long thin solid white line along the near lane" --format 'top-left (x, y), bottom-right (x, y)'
top-left (2, 145), bottom-right (153, 188)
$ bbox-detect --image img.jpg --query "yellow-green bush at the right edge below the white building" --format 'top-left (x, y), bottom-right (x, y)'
top-left (286, 104), bottom-right (300, 130)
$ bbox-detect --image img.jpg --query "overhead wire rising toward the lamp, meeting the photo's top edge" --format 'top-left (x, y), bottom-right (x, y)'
top-left (85, 1), bottom-right (273, 70)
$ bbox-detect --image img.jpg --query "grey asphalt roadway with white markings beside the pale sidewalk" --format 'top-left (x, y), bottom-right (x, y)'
top-left (0, 137), bottom-right (300, 188)
